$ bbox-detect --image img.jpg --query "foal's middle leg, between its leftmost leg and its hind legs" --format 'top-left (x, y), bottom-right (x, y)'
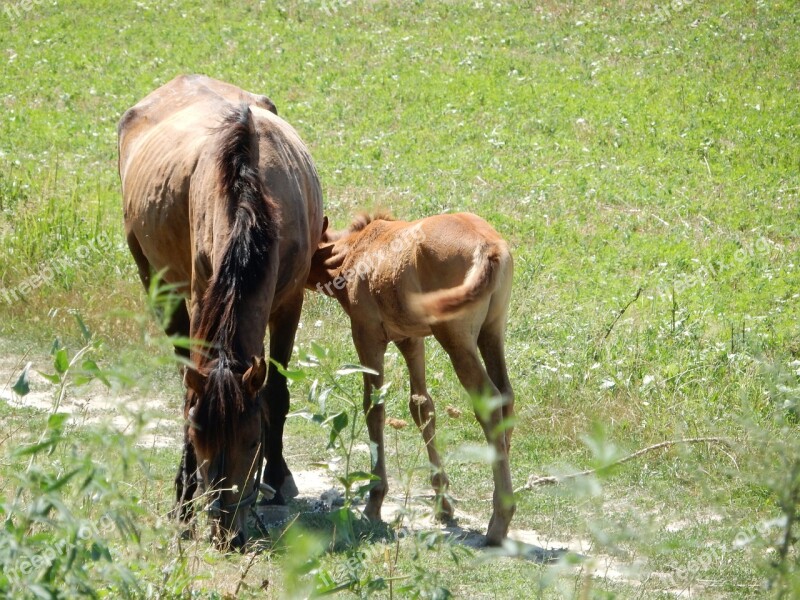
top-left (395, 338), bottom-right (453, 520)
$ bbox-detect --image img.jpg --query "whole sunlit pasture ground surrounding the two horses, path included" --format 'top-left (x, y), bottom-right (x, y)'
top-left (0, 0), bottom-right (800, 598)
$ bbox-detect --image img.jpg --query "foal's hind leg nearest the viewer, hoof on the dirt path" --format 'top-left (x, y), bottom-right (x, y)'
top-left (431, 321), bottom-right (516, 546)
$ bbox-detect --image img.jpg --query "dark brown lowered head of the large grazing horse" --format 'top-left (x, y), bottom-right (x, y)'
top-left (184, 353), bottom-right (267, 549)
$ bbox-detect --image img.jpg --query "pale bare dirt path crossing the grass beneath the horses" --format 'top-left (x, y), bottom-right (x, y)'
top-left (0, 358), bottom-right (664, 585)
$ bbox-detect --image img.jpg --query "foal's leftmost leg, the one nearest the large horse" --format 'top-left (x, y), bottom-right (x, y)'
top-left (353, 323), bottom-right (389, 521)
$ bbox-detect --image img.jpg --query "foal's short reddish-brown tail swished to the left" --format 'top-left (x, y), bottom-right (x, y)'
top-left (413, 244), bottom-right (506, 323)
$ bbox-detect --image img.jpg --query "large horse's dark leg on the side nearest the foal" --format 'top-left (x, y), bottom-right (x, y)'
top-left (259, 292), bottom-right (303, 505)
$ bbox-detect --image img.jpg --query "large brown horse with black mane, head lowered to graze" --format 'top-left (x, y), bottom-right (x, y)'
top-left (118, 75), bottom-right (322, 547)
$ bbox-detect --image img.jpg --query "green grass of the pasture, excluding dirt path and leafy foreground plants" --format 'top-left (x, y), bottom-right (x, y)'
top-left (0, 0), bottom-right (800, 598)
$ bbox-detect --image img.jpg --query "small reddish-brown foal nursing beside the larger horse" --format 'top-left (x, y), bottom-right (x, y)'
top-left (308, 213), bottom-right (515, 545)
